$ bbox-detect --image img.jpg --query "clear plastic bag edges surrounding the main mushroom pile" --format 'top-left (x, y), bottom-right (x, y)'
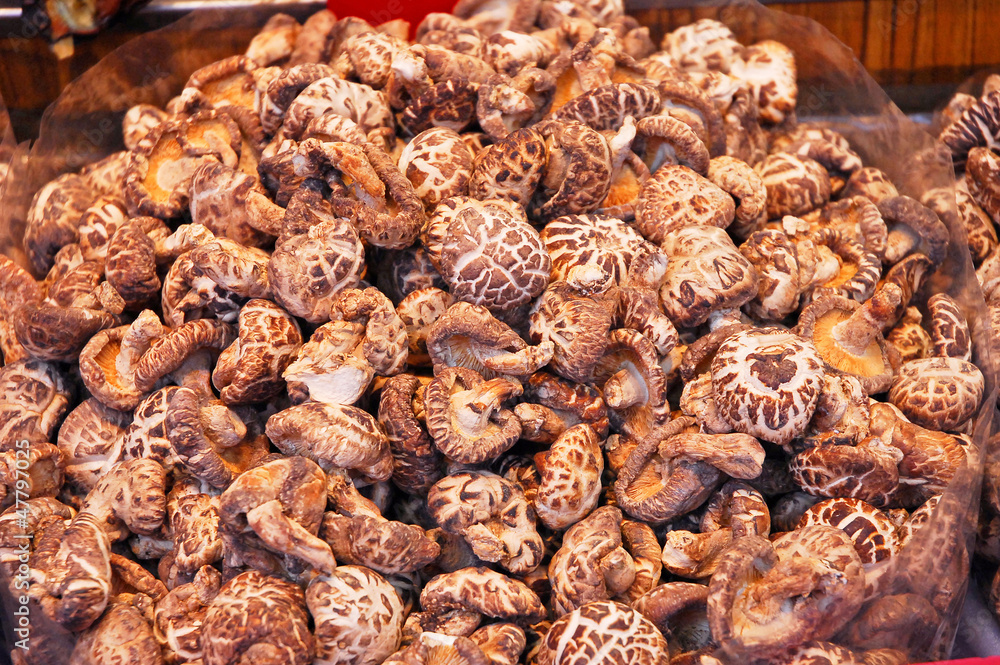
top-left (0, 2), bottom-right (996, 662)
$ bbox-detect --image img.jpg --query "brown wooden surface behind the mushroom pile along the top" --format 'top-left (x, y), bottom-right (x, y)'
top-left (0, 0), bottom-right (1000, 140)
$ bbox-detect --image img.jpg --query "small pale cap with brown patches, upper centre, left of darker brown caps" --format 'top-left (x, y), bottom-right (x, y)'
top-left (399, 127), bottom-right (474, 210)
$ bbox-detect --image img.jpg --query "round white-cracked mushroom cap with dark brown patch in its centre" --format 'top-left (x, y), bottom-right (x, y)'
top-left (712, 328), bottom-right (824, 445)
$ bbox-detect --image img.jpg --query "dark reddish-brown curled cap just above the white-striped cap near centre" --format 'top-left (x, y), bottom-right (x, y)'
top-left (529, 120), bottom-right (613, 220)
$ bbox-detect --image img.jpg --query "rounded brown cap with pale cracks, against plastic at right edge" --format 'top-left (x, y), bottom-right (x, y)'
top-left (889, 358), bottom-right (985, 432)
